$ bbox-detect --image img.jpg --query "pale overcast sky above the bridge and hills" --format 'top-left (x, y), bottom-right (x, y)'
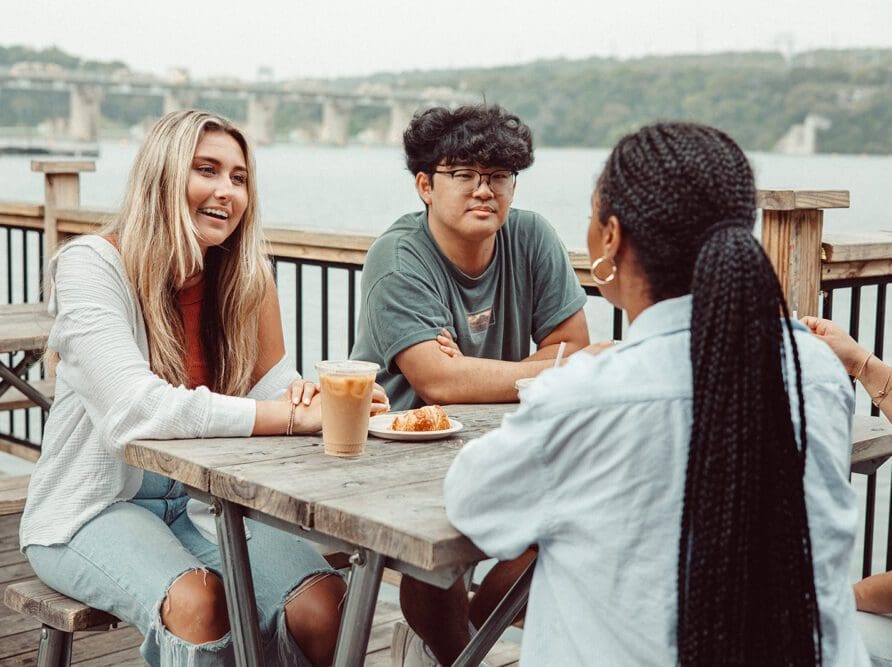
top-left (6, 0), bottom-right (892, 79)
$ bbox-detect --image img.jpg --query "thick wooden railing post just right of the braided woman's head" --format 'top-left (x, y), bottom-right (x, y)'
top-left (756, 190), bottom-right (849, 317)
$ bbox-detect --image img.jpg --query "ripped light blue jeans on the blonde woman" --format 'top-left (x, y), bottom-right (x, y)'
top-left (25, 472), bottom-right (332, 667)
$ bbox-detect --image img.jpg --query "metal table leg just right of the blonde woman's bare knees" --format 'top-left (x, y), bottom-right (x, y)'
top-left (334, 549), bottom-right (384, 667)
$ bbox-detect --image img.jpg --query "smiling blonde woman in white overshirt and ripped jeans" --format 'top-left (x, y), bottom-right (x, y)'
top-left (21, 111), bottom-right (385, 665)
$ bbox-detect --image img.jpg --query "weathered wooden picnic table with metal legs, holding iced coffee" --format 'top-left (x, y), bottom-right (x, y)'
top-left (125, 404), bottom-right (892, 665)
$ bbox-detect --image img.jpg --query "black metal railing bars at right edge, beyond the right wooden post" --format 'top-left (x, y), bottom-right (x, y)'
top-left (821, 276), bottom-right (892, 577)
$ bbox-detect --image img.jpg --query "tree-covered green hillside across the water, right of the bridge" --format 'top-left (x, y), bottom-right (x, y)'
top-left (362, 49), bottom-right (892, 154)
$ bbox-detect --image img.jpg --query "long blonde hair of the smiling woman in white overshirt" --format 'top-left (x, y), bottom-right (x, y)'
top-left (99, 110), bottom-right (271, 396)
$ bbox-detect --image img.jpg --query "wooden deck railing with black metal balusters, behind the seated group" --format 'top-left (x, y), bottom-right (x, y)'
top-left (0, 162), bottom-right (892, 572)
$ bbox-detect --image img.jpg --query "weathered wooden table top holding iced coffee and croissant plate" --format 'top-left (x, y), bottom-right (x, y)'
top-left (124, 403), bottom-right (517, 571)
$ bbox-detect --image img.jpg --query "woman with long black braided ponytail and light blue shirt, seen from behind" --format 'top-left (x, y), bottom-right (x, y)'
top-left (445, 123), bottom-right (867, 666)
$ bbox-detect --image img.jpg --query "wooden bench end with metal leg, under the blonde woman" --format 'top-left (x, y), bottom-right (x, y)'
top-left (3, 579), bottom-right (118, 667)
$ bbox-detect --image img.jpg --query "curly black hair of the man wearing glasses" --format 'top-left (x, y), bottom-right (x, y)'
top-left (403, 104), bottom-right (533, 175)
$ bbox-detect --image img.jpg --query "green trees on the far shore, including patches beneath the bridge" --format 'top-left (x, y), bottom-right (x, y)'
top-left (0, 46), bottom-right (892, 154)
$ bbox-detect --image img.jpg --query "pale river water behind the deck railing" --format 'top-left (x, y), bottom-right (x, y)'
top-left (0, 142), bottom-right (892, 578)
